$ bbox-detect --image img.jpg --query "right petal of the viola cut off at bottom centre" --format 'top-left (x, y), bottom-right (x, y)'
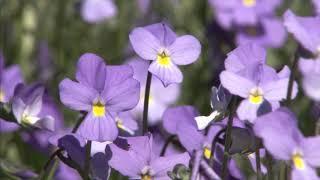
top-left (151, 153), bottom-right (190, 178)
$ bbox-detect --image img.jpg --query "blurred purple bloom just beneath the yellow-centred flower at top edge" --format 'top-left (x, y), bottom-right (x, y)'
top-left (236, 17), bottom-right (287, 48)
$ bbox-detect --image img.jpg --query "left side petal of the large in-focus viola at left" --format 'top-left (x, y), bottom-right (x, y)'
top-left (59, 79), bottom-right (98, 111)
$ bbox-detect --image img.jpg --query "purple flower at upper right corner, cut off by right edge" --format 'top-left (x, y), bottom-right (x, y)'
top-left (284, 10), bottom-right (320, 55)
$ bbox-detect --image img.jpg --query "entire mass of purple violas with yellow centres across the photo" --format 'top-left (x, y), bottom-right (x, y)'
top-left (0, 0), bottom-right (320, 180)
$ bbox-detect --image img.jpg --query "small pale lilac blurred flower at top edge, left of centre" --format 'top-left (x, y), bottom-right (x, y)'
top-left (81, 0), bottom-right (118, 23)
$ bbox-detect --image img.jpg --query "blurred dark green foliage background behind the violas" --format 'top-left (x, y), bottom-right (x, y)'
top-left (0, 0), bottom-right (317, 179)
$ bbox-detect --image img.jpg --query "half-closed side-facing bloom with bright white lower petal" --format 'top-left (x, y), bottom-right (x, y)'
top-left (195, 85), bottom-right (231, 130)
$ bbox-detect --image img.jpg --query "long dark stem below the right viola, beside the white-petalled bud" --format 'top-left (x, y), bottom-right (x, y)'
top-left (221, 97), bottom-right (237, 179)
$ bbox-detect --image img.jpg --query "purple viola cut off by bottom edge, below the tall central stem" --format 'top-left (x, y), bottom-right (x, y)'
top-left (109, 136), bottom-right (190, 180)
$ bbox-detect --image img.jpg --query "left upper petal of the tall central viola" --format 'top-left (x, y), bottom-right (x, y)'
top-left (129, 28), bottom-right (161, 60)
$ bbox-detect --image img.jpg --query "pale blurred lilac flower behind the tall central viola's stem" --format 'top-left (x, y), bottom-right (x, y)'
top-left (128, 59), bottom-right (180, 125)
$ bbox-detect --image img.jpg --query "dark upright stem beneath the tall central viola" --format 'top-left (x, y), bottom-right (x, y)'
top-left (142, 72), bottom-right (152, 135)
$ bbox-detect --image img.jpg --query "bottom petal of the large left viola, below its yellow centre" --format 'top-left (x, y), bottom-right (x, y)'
top-left (77, 112), bottom-right (118, 142)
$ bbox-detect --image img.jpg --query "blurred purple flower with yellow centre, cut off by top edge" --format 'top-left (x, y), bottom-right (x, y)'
top-left (209, 0), bottom-right (281, 29)
